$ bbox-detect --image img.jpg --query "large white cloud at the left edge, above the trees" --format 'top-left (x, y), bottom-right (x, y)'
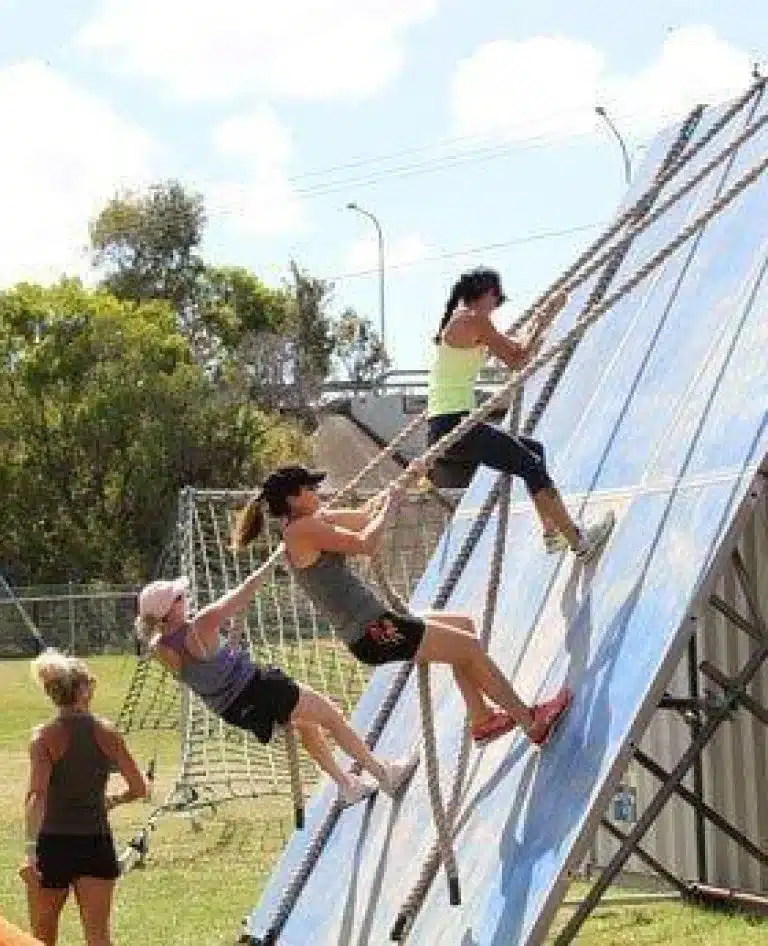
top-left (0, 61), bottom-right (154, 285)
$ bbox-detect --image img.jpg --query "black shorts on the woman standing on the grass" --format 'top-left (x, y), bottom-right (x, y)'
top-left (37, 833), bottom-right (120, 890)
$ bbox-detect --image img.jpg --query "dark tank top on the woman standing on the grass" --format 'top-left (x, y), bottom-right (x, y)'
top-left (40, 713), bottom-right (113, 835)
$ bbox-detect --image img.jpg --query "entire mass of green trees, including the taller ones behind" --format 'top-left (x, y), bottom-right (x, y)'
top-left (0, 181), bottom-right (384, 583)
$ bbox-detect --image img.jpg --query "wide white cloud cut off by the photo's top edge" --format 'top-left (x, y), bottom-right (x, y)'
top-left (77, 0), bottom-right (439, 101)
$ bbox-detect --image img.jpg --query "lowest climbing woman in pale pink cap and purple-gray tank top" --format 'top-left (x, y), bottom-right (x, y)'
top-left (136, 568), bottom-right (416, 805)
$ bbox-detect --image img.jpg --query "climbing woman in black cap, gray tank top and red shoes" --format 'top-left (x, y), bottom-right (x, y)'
top-left (233, 464), bottom-right (572, 745)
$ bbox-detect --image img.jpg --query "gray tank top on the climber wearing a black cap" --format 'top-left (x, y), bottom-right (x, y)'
top-left (291, 552), bottom-right (388, 644)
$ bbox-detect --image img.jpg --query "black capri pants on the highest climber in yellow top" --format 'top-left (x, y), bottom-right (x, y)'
top-left (427, 412), bottom-right (554, 496)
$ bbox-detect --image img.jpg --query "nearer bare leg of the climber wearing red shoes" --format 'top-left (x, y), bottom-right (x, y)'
top-left (417, 616), bottom-right (533, 731)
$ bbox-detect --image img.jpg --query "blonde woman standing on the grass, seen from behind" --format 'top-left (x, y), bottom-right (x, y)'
top-left (20, 650), bottom-right (147, 946)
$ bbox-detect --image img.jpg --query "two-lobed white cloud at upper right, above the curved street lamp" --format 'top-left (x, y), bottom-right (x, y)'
top-left (452, 26), bottom-right (751, 140)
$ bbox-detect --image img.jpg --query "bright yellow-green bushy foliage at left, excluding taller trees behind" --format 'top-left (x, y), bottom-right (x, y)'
top-left (0, 280), bottom-right (303, 583)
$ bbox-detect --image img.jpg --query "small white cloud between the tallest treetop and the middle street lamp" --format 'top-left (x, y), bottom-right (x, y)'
top-left (207, 105), bottom-right (306, 236)
